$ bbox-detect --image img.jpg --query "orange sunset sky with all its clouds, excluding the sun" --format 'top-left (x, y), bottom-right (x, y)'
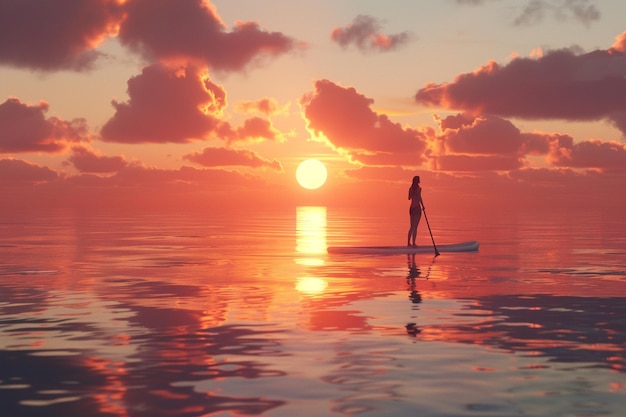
top-left (0, 0), bottom-right (626, 210)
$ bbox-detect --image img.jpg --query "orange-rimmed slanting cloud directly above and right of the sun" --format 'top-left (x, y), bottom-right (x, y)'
top-left (300, 80), bottom-right (427, 166)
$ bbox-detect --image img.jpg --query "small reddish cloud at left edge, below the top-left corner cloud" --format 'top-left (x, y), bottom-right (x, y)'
top-left (0, 98), bottom-right (87, 153)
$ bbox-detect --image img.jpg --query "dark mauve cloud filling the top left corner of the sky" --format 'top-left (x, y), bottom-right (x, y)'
top-left (0, 0), bottom-right (121, 71)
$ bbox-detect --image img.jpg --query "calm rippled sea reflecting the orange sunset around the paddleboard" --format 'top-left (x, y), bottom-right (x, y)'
top-left (0, 207), bottom-right (626, 417)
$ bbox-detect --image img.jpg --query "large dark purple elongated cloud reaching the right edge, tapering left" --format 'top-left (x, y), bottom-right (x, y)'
top-left (415, 34), bottom-right (626, 134)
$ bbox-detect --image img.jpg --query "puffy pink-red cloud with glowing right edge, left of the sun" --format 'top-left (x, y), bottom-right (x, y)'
top-left (101, 64), bottom-right (226, 143)
